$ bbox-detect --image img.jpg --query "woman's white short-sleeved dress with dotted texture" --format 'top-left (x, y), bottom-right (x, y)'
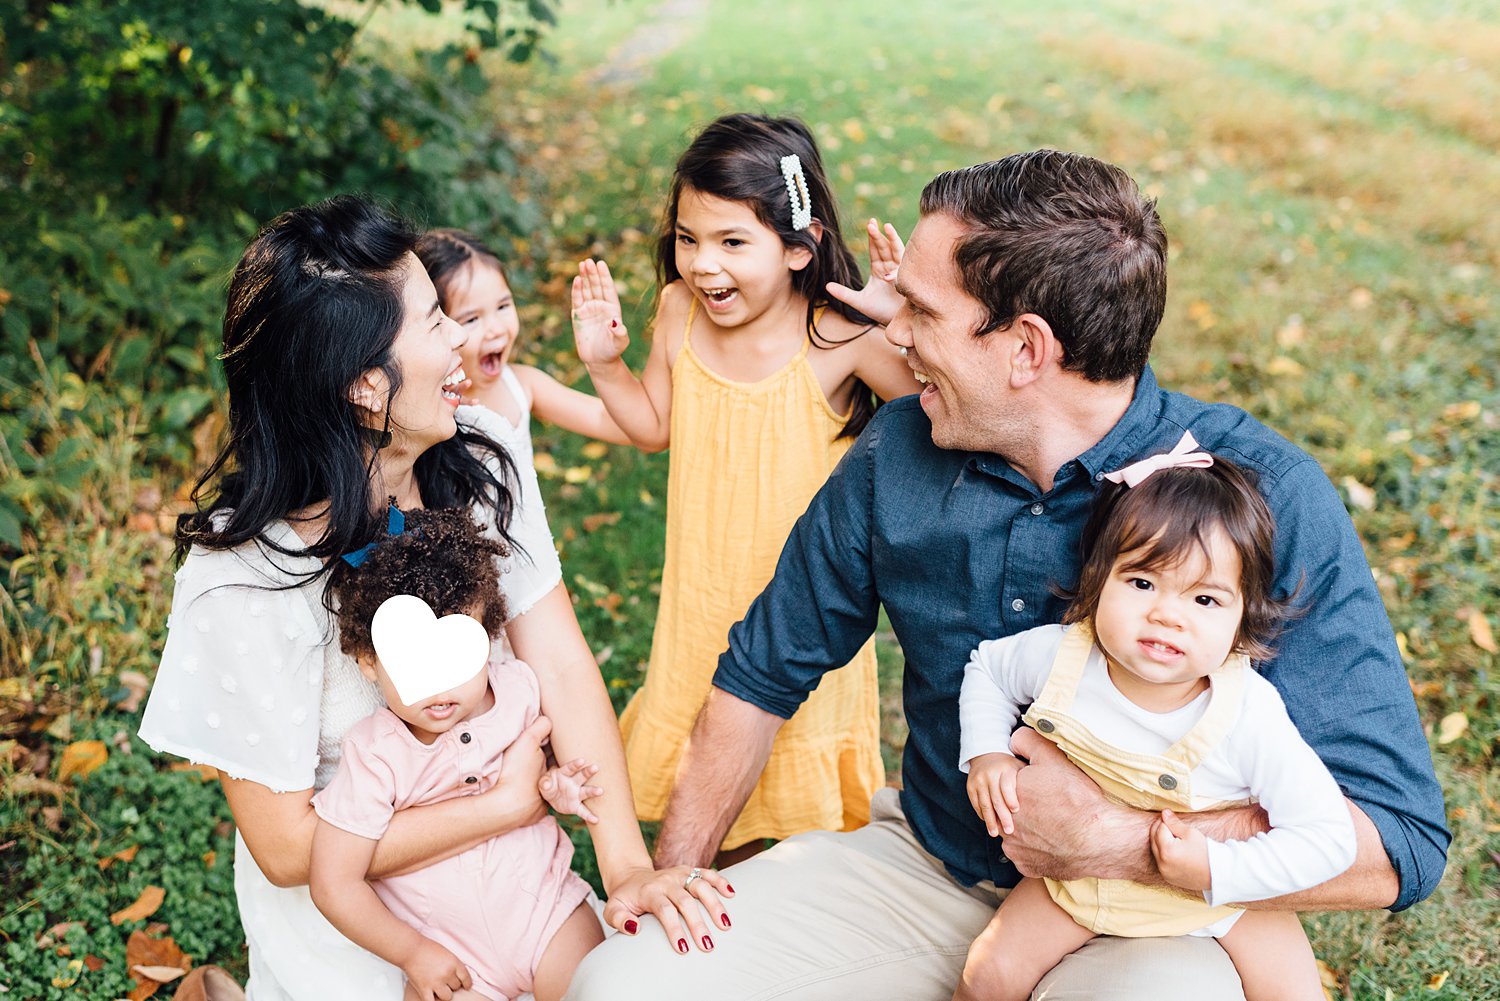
top-left (140, 407), bottom-right (563, 1001)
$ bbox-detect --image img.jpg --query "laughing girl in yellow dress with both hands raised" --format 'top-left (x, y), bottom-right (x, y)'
top-left (573, 114), bottom-right (921, 858)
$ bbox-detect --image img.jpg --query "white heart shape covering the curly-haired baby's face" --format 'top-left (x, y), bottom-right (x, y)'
top-left (371, 594), bottom-right (489, 705)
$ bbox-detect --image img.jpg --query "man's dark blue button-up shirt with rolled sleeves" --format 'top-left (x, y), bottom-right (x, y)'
top-left (714, 368), bottom-right (1451, 909)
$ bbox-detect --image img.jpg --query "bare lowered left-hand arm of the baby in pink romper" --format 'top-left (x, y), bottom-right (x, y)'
top-left (308, 821), bottom-right (473, 998)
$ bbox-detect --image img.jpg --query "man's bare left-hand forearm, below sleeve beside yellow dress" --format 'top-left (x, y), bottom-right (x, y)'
top-left (656, 689), bottom-right (785, 867)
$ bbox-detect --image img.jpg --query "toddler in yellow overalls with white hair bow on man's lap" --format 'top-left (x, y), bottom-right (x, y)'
top-left (956, 434), bottom-right (1355, 1001)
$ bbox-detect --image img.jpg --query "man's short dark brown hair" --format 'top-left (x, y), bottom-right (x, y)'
top-left (921, 150), bottom-right (1167, 383)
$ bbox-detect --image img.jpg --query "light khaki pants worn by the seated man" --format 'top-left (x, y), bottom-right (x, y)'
top-left (567, 789), bottom-right (1245, 1001)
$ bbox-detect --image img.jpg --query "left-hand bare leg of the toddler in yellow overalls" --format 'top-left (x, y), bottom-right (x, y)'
top-left (953, 879), bottom-right (1094, 1001)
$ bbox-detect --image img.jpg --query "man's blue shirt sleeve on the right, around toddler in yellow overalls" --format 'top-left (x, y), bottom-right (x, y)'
top-left (1265, 459), bottom-right (1452, 911)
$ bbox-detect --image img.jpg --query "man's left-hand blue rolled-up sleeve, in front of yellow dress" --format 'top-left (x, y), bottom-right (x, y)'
top-left (714, 422), bottom-right (879, 719)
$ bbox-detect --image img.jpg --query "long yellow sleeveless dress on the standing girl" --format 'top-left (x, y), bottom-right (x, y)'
top-left (620, 300), bottom-right (885, 848)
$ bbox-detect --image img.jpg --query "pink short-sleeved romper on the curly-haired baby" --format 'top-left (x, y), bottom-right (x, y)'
top-left (312, 660), bottom-right (588, 1001)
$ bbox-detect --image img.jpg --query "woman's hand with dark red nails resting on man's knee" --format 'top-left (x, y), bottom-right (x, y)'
top-left (605, 866), bottom-right (735, 954)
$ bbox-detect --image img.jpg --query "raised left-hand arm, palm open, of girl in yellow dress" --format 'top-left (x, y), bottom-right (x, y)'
top-left (573, 261), bottom-right (672, 452)
